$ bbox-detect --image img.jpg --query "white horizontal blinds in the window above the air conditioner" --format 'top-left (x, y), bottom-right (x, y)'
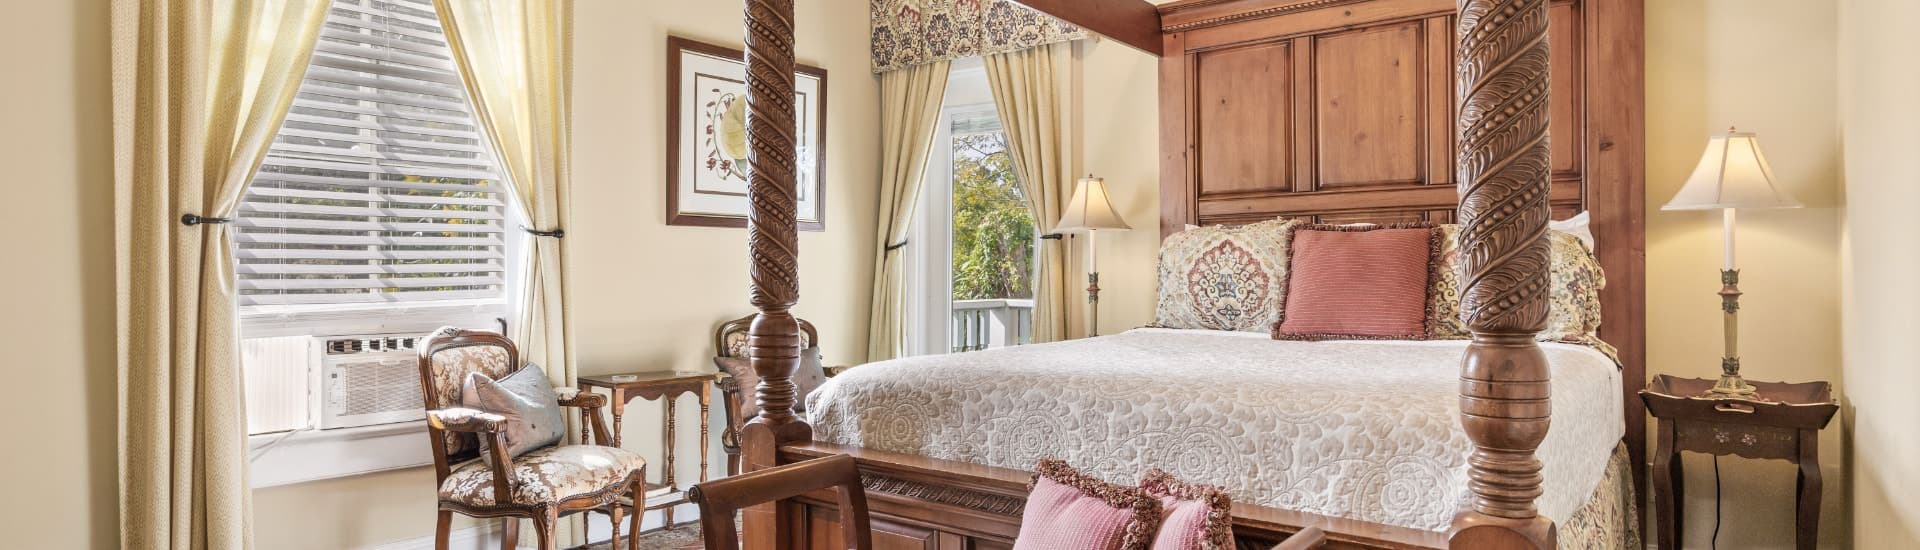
top-left (234, 0), bottom-right (511, 308)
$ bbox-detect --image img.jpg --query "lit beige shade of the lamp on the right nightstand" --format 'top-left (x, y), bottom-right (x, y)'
top-left (1661, 129), bottom-right (1801, 210)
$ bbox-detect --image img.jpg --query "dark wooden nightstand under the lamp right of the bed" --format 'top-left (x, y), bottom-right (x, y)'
top-left (1640, 375), bottom-right (1839, 550)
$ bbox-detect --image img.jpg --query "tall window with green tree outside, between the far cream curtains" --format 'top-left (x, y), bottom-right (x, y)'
top-left (908, 58), bottom-right (1037, 354)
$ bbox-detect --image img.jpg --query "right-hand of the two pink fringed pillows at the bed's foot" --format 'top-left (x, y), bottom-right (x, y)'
top-left (1140, 467), bottom-right (1233, 550)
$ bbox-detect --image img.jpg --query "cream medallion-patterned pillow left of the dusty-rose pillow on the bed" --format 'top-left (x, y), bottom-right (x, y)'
top-left (1154, 217), bottom-right (1298, 333)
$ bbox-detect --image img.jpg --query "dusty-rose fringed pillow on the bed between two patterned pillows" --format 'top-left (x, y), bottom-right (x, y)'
top-left (1273, 223), bottom-right (1440, 340)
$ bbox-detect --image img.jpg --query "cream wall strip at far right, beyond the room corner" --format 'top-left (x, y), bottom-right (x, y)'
top-left (1839, 0), bottom-right (1920, 550)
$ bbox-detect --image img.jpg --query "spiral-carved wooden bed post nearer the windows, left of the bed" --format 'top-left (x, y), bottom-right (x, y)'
top-left (739, 0), bottom-right (814, 548)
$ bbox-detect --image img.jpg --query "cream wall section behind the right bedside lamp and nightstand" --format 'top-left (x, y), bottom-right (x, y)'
top-left (1645, 0), bottom-right (1847, 548)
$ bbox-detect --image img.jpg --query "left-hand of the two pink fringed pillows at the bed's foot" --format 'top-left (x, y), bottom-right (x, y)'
top-left (1014, 458), bottom-right (1160, 550)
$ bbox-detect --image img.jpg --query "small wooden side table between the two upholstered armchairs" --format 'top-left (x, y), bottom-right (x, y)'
top-left (580, 371), bottom-right (716, 527)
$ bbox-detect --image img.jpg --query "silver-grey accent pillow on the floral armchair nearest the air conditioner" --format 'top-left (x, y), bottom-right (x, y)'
top-left (461, 363), bottom-right (566, 463)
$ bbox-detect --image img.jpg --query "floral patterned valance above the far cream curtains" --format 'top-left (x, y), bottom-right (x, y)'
top-left (870, 0), bottom-right (1087, 73)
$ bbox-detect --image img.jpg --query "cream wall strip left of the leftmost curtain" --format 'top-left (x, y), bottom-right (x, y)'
top-left (0, 0), bottom-right (119, 548)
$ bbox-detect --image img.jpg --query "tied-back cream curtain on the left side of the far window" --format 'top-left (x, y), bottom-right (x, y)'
top-left (866, 62), bottom-right (948, 362)
